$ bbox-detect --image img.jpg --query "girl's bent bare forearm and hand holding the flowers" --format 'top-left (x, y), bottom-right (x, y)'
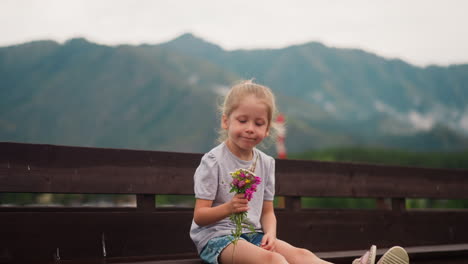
top-left (193, 193), bottom-right (249, 226)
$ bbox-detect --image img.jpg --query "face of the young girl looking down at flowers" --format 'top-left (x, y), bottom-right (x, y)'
top-left (222, 95), bottom-right (269, 158)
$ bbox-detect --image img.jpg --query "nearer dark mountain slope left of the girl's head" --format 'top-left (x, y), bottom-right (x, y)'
top-left (0, 39), bottom-right (234, 151)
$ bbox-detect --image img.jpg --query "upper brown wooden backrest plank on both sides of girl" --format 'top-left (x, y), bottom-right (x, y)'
top-left (0, 143), bottom-right (468, 199)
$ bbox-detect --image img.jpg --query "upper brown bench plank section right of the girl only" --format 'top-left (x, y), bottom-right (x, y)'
top-left (276, 160), bottom-right (468, 199)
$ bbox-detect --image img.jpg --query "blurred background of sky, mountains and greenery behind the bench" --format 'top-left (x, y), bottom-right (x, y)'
top-left (0, 0), bottom-right (468, 207)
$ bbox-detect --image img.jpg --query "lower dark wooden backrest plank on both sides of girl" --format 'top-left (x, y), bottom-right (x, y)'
top-left (0, 210), bottom-right (468, 261)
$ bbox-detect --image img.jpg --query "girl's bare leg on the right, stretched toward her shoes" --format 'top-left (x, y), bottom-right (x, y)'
top-left (275, 239), bottom-right (331, 264)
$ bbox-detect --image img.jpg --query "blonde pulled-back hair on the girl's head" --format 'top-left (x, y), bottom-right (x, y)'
top-left (218, 80), bottom-right (277, 142)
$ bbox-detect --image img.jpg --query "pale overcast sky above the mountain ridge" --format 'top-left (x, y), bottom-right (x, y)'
top-left (0, 0), bottom-right (468, 66)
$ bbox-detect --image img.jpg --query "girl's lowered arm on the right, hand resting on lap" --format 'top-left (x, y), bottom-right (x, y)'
top-left (260, 201), bottom-right (276, 251)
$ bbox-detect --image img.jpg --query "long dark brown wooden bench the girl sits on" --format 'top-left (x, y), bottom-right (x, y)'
top-left (0, 143), bottom-right (468, 264)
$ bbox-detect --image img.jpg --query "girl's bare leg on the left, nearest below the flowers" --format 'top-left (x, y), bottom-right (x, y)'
top-left (219, 240), bottom-right (288, 264)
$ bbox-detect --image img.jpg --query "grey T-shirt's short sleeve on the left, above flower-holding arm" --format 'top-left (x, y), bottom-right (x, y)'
top-left (193, 153), bottom-right (219, 200)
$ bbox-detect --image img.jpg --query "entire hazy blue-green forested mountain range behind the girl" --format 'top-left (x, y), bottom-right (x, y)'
top-left (0, 34), bottom-right (468, 154)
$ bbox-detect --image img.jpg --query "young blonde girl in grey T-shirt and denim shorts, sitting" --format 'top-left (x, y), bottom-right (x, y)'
top-left (190, 81), bottom-right (409, 264)
